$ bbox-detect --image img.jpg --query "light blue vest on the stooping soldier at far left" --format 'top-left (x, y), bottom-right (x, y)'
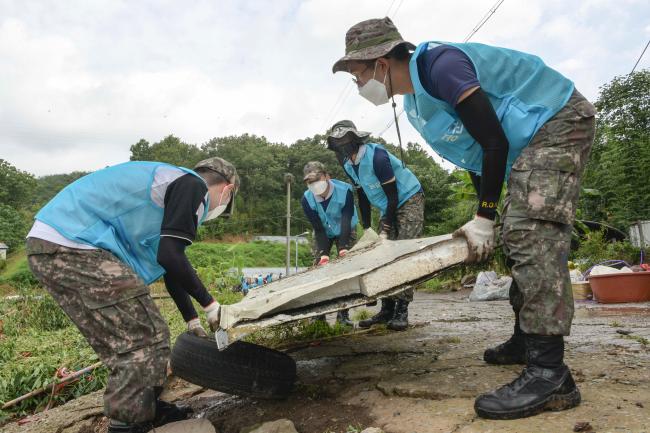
top-left (35, 161), bottom-right (210, 284)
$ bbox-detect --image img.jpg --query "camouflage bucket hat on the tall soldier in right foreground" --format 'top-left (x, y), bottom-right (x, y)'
top-left (332, 17), bottom-right (415, 73)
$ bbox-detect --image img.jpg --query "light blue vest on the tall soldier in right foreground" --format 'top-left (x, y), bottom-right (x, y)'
top-left (404, 42), bottom-right (574, 174)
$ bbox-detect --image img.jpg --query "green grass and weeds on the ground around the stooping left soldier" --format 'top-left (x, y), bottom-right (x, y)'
top-left (0, 242), bottom-right (312, 425)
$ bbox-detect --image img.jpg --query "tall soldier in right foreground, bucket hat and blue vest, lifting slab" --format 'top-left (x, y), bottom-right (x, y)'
top-left (333, 18), bottom-right (595, 419)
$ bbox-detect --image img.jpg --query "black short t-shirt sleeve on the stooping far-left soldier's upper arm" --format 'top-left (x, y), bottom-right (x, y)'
top-left (160, 174), bottom-right (208, 244)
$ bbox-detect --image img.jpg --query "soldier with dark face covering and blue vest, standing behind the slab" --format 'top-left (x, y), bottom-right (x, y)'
top-left (327, 120), bottom-right (424, 331)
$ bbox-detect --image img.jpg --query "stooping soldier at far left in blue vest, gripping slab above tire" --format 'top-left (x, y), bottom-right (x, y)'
top-left (26, 158), bottom-right (239, 433)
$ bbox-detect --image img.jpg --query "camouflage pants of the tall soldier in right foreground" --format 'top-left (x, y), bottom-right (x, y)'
top-left (501, 90), bottom-right (596, 335)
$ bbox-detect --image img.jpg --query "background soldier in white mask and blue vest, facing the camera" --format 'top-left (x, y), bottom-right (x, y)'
top-left (301, 161), bottom-right (359, 326)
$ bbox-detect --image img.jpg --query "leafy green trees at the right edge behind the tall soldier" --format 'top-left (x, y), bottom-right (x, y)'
top-left (581, 70), bottom-right (650, 229)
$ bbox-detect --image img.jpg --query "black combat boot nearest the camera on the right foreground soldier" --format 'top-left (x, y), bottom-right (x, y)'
top-left (474, 335), bottom-right (580, 419)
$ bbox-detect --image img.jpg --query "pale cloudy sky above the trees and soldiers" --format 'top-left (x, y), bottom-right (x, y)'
top-left (0, 0), bottom-right (650, 175)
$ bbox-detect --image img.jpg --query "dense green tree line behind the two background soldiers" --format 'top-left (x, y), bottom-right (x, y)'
top-left (124, 134), bottom-right (451, 238)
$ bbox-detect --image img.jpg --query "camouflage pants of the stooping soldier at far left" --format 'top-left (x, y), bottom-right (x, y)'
top-left (27, 238), bottom-right (169, 422)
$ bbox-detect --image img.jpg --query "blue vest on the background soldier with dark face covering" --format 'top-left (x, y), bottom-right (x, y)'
top-left (343, 143), bottom-right (422, 217)
